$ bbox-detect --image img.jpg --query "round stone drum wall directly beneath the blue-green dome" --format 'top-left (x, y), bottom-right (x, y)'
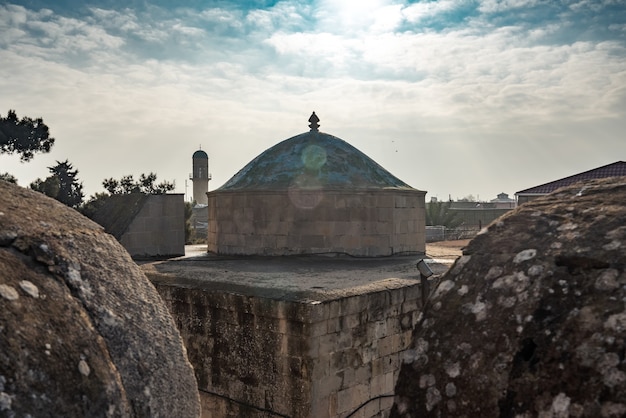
top-left (208, 189), bottom-right (425, 257)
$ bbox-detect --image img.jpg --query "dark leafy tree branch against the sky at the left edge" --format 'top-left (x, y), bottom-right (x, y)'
top-left (0, 110), bottom-right (54, 162)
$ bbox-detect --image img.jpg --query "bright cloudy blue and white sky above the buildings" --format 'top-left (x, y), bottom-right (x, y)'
top-left (0, 0), bottom-right (626, 200)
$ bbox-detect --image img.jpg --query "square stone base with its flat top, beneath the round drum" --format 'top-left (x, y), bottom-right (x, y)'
top-left (142, 250), bottom-right (448, 418)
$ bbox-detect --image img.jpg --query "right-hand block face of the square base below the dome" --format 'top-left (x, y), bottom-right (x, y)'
top-left (308, 285), bottom-right (419, 418)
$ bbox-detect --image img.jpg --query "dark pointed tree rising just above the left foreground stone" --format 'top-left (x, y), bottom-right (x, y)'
top-left (30, 160), bottom-right (85, 208)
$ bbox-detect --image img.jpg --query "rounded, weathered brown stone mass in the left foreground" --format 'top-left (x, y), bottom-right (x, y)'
top-left (0, 181), bottom-right (200, 418)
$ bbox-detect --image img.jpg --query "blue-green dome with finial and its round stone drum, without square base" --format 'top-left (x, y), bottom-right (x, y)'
top-left (208, 112), bottom-right (426, 257)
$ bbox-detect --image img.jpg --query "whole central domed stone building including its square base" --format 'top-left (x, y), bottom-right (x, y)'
top-left (143, 114), bottom-right (432, 418)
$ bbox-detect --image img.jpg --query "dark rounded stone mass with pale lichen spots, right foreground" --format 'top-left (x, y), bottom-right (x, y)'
top-left (392, 177), bottom-right (626, 417)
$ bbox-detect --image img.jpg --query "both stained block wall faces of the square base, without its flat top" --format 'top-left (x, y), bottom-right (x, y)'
top-left (156, 279), bottom-right (419, 418)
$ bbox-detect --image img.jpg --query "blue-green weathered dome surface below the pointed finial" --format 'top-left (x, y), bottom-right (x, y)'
top-left (218, 130), bottom-right (413, 190)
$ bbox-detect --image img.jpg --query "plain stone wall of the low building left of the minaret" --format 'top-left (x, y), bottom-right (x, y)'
top-left (120, 194), bottom-right (185, 257)
